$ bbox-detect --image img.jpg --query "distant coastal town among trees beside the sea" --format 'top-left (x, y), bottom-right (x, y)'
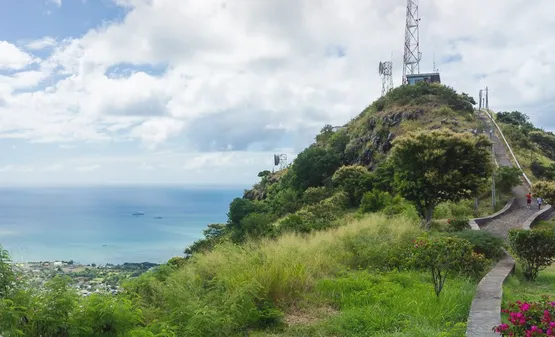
top-left (13, 260), bottom-right (159, 296)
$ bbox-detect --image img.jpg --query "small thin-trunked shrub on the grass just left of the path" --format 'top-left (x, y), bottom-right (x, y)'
top-left (411, 237), bottom-right (486, 297)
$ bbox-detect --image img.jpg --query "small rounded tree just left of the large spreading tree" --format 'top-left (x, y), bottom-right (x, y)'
top-left (332, 165), bottom-right (371, 207)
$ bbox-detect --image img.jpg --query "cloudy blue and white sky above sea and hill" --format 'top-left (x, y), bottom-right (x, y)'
top-left (0, 0), bottom-right (555, 185)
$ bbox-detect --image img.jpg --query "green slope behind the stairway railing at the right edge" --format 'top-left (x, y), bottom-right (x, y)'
top-left (495, 111), bottom-right (555, 181)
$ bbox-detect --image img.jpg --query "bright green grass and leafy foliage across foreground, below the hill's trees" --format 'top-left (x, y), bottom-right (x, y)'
top-left (0, 214), bottom-right (496, 337)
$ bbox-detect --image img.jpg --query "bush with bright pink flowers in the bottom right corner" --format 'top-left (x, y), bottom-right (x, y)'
top-left (493, 296), bottom-right (555, 337)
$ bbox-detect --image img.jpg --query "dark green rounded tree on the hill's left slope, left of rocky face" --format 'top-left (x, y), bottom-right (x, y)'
top-left (288, 146), bottom-right (341, 191)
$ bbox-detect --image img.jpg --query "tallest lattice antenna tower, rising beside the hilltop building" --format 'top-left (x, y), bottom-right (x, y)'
top-left (403, 0), bottom-right (422, 84)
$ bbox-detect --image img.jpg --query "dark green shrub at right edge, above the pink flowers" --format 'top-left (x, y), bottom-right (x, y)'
top-left (509, 229), bottom-right (555, 281)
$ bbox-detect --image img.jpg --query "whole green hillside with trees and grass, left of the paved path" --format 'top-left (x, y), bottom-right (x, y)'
top-left (0, 83), bottom-right (518, 337)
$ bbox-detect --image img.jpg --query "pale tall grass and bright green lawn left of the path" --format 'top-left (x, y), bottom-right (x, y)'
top-left (137, 214), bottom-right (475, 337)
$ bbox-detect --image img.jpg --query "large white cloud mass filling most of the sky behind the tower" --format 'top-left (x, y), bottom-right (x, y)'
top-left (0, 0), bottom-right (555, 184)
